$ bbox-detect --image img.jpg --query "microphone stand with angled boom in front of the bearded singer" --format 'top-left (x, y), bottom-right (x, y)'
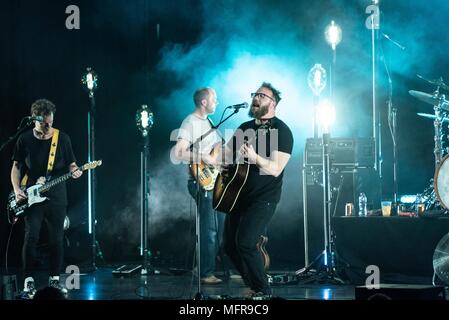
top-left (188, 107), bottom-right (240, 300)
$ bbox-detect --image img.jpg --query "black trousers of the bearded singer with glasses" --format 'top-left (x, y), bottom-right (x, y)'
top-left (223, 201), bottom-right (276, 294)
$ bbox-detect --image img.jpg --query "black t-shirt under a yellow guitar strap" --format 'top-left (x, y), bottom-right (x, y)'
top-left (12, 130), bottom-right (76, 205)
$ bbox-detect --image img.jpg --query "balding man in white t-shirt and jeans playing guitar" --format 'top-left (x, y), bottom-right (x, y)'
top-left (174, 88), bottom-right (224, 284)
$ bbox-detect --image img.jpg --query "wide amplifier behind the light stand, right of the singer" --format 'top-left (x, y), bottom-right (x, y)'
top-left (304, 138), bottom-right (375, 168)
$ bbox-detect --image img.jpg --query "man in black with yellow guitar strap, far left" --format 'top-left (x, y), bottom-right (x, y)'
top-left (11, 99), bottom-right (82, 298)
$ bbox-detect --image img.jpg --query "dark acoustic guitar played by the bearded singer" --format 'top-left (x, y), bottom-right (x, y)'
top-left (212, 122), bottom-right (271, 213)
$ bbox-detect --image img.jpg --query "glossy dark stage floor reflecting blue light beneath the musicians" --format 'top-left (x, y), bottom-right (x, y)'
top-left (51, 267), bottom-right (355, 300)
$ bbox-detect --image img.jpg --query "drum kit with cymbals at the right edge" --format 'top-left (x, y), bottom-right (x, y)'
top-left (409, 75), bottom-right (449, 210)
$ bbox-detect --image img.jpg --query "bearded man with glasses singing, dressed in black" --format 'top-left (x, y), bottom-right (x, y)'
top-left (223, 82), bottom-right (293, 299)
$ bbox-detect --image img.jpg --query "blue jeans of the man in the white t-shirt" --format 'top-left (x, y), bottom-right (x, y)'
top-left (187, 180), bottom-right (225, 278)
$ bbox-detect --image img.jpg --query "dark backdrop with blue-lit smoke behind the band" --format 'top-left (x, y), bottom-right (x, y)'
top-left (0, 0), bottom-right (449, 269)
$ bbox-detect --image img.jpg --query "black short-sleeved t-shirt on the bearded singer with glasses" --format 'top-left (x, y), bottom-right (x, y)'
top-left (229, 117), bottom-right (293, 205)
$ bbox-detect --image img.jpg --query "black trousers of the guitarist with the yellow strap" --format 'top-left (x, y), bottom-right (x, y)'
top-left (22, 201), bottom-right (67, 278)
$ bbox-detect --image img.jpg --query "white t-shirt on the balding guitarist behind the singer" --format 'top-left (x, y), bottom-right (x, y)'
top-left (178, 114), bottom-right (221, 154)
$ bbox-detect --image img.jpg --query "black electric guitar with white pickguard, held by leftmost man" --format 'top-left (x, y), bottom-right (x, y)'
top-left (7, 160), bottom-right (102, 222)
